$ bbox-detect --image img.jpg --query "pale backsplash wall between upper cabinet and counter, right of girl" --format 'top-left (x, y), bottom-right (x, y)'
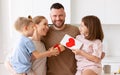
top-left (102, 24), bottom-right (120, 56)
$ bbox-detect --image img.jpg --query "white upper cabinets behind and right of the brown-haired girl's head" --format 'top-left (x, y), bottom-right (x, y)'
top-left (71, 0), bottom-right (120, 24)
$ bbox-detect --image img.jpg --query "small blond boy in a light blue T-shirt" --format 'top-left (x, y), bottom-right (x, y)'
top-left (4, 17), bottom-right (61, 75)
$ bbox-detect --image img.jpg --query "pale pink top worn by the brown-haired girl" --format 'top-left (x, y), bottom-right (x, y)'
top-left (75, 35), bottom-right (102, 70)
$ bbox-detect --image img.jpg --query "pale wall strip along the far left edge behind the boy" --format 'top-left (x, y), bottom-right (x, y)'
top-left (0, 0), bottom-right (12, 63)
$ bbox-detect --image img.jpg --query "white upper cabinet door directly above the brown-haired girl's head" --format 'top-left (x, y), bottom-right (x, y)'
top-left (71, 0), bottom-right (104, 24)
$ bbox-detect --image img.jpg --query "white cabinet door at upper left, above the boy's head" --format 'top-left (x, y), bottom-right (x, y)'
top-left (8, 0), bottom-right (33, 25)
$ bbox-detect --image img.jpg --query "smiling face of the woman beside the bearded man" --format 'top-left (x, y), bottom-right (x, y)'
top-left (36, 19), bottom-right (49, 36)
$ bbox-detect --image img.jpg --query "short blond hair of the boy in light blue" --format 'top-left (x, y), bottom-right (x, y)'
top-left (14, 17), bottom-right (32, 31)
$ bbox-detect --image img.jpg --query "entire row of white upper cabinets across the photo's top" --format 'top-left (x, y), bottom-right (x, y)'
top-left (10, 0), bottom-right (120, 24)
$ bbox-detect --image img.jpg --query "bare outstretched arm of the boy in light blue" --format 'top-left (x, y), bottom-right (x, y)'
top-left (32, 47), bottom-right (59, 59)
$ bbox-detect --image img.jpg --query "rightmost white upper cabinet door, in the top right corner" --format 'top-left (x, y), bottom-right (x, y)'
top-left (105, 0), bottom-right (120, 24)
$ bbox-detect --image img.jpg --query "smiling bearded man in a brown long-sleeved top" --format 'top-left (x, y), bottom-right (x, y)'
top-left (43, 3), bottom-right (104, 75)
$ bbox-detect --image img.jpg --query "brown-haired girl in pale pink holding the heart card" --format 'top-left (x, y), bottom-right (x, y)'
top-left (73, 15), bottom-right (104, 75)
